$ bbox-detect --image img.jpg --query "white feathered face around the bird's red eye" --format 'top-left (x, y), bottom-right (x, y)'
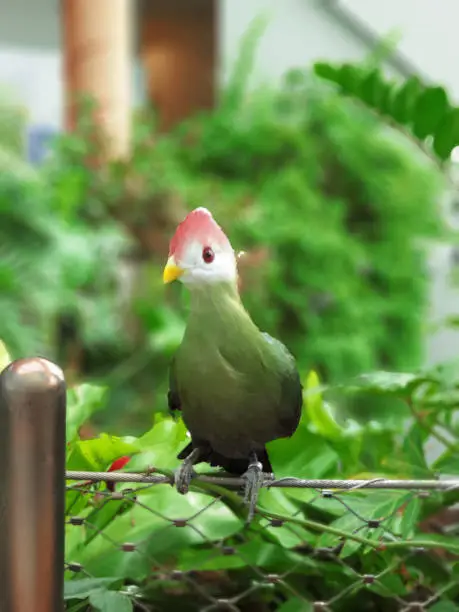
top-left (177, 241), bottom-right (237, 285)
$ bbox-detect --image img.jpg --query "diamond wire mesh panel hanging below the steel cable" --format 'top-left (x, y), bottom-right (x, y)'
top-left (65, 472), bottom-right (459, 612)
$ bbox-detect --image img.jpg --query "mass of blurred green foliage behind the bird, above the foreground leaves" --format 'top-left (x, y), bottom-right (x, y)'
top-left (0, 26), bottom-right (446, 431)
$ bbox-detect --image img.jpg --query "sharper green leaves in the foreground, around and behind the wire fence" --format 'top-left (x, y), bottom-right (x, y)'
top-left (65, 364), bottom-right (459, 612)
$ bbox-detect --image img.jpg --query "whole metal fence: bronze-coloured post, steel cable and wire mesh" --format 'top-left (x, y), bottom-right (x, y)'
top-left (0, 359), bottom-right (459, 612)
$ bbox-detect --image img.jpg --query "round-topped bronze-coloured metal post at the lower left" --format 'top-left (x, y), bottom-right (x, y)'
top-left (0, 357), bottom-right (66, 612)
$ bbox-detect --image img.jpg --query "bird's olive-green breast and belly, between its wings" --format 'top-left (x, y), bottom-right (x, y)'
top-left (175, 280), bottom-right (288, 457)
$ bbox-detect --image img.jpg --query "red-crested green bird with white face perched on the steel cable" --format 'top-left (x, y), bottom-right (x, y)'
top-left (163, 207), bottom-right (302, 522)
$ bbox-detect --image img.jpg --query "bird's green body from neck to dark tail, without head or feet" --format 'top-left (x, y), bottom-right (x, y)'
top-left (169, 283), bottom-right (302, 473)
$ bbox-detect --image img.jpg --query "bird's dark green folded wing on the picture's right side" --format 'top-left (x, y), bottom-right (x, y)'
top-left (263, 332), bottom-right (303, 436)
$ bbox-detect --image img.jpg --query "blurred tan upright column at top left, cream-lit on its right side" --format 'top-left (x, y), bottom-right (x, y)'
top-left (62, 0), bottom-right (134, 158)
